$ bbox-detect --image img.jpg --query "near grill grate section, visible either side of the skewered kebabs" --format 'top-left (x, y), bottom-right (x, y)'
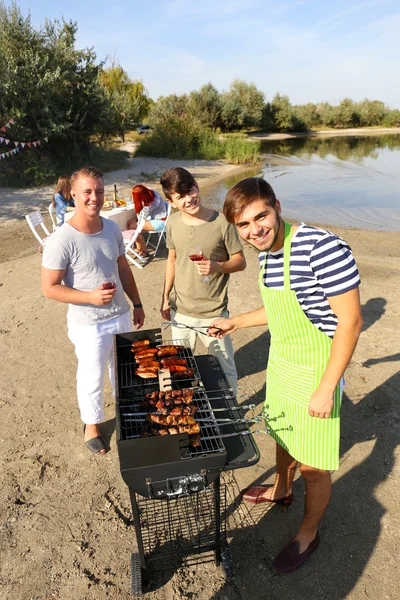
top-left (119, 388), bottom-right (225, 456)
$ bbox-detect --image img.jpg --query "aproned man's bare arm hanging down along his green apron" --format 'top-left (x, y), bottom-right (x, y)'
top-left (308, 287), bottom-right (363, 419)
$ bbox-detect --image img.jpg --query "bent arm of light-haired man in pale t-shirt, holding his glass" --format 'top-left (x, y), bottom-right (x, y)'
top-left (42, 267), bottom-right (115, 306)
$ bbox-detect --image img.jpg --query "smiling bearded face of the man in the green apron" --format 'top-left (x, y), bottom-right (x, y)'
top-left (235, 200), bottom-right (284, 252)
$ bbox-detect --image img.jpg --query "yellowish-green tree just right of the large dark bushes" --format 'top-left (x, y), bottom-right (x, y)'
top-left (100, 64), bottom-right (150, 141)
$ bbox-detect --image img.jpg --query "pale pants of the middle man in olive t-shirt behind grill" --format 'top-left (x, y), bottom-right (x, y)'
top-left (171, 310), bottom-right (237, 394)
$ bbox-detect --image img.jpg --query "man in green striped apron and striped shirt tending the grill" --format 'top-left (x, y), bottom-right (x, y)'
top-left (209, 177), bottom-right (362, 573)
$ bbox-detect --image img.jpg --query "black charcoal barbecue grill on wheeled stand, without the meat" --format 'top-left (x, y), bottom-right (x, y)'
top-left (114, 329), bottom-right (259, 597)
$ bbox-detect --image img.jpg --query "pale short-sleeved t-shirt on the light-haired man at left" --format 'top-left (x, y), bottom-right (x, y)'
top-left (42, 218), bottom-right (129, 325)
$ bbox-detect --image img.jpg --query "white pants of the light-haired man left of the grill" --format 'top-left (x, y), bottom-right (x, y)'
top-left (68, 311), bottom-right (133, 425)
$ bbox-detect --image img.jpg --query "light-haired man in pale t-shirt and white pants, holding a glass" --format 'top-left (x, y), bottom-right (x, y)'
top-left (42, 167), bottom-right (145, 454)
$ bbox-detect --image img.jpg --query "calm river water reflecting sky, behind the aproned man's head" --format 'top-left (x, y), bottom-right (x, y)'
top-left (207, 134), bottom-right (400, 231)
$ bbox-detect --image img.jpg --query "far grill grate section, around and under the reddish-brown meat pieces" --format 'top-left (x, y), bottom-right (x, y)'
top-left (118, 340), bottom-right (200, 390)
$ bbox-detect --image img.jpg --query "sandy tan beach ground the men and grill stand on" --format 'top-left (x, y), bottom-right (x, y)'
top-left (0, 158), bottom-right (400, 600)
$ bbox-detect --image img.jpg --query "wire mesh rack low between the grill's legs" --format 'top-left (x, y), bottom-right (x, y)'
top-left (136, 486), bottom-right (226, 559)
